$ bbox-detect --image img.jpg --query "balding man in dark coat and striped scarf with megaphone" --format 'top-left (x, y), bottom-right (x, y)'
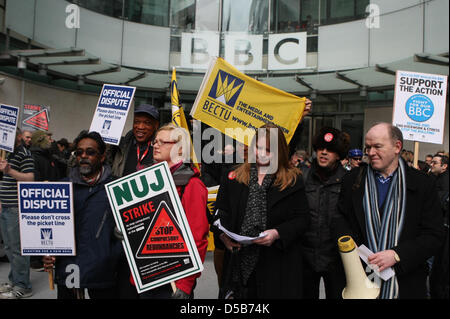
top-left (335, 123), bottom-right (443, 299)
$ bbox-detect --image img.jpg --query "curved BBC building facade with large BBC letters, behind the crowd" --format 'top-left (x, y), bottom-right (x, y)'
top-left (0, 0), bottom-right (449, 160)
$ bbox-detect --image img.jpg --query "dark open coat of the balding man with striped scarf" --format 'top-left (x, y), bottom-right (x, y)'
top-left (334, 166), bottom-right (444, 299)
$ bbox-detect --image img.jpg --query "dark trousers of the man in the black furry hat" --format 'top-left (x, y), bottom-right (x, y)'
top-left (303, 262), bottom-right (346, 299)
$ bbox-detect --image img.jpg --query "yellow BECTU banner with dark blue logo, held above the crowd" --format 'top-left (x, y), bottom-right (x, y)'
top-left (190, 58), bottom-right (305, 145)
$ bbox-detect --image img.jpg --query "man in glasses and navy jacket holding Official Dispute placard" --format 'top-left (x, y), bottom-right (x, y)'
top-left (44, 132), bottom-right (122, 299)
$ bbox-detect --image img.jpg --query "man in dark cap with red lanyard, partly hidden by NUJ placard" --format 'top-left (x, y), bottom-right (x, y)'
top-left (111, 104), bottom-right (159, 299)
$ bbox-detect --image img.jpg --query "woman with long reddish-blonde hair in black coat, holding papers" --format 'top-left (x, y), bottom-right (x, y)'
top-left (216, 124), bottom-right (309, 298)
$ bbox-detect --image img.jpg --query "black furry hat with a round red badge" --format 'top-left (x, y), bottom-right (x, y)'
top-left (313, 126), bottom-right (350, 159)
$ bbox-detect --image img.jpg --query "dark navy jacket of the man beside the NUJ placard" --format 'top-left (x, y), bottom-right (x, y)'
top-left (55, 166), bottom-right (122, 289)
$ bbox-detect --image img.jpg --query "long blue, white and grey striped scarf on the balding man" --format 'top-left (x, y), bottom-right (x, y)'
top-left (363, 158), bottom-right (406, 299)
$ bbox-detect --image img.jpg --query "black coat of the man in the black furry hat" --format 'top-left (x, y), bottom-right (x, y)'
top-left (303, 163), bottom-right (347, 272)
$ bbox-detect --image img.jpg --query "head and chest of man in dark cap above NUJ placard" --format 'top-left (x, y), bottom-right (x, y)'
top-left (111, 104), bottom-right (159, 177)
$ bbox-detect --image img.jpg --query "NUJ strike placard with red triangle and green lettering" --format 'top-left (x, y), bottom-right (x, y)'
top-left (106, 162), bottom-right (203, 293)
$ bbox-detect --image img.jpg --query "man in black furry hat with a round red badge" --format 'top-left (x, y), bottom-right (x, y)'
top-left (303, 127), bottom-right (350, 299)
